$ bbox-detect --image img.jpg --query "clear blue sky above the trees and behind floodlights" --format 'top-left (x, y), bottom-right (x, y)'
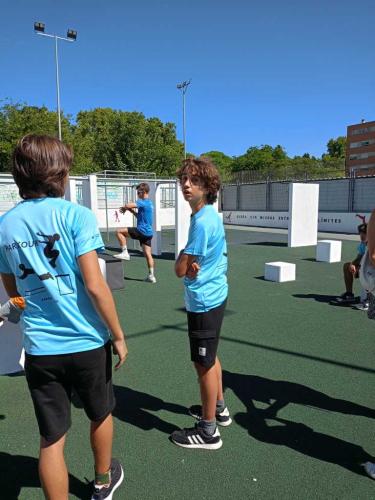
top-left (0, 0), bottom-right (375, 156)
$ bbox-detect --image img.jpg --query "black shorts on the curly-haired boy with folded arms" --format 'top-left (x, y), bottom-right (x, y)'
top-left (187, 300), bottom-right (227, 368)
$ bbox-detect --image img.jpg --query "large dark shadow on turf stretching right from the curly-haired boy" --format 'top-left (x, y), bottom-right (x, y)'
top-left (223, 371), bottom-right (375, 475)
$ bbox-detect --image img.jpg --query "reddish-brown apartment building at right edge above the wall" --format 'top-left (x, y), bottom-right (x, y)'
top-left (345, 120), bottom-right (375, 177)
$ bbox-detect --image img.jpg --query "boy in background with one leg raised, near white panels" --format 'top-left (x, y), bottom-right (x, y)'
top-left (114, 182), bottom-right (156, 283)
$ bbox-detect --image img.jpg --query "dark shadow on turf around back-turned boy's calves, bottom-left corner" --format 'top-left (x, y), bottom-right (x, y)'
top-left (0, 452), bottom-right (92, 500)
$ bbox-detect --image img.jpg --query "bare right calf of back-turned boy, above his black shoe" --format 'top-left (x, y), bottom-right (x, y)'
top-left (90, 414), bottom-right (113, 474)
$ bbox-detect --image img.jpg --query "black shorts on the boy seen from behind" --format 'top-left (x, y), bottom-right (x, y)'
top-left (25, 342), bottom-right (115, 443)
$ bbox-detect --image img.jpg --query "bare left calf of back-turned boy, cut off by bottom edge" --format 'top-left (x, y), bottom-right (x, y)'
top-left (39, 435), bottom-right (69, 500)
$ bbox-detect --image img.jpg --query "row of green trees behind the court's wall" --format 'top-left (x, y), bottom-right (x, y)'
top-left (0, 102), bottom-right (346, 180)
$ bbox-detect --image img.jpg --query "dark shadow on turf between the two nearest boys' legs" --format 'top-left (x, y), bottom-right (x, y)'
top-left (113, 385), bottom-right (188, 434)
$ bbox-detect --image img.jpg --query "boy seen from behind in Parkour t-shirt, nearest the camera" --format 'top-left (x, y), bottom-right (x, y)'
top-left (0, 135), bottom-right (127, 500)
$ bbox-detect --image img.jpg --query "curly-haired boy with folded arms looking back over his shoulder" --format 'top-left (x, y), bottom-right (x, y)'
top-left (171, 158), bottom-right (232, 450)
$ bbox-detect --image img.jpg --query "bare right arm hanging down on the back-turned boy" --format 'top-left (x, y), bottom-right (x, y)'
top-left (78, 250), bottom-right (128, 369)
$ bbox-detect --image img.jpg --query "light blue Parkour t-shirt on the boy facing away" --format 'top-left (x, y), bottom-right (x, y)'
top-left (0, 198), bottom-right (109, 355)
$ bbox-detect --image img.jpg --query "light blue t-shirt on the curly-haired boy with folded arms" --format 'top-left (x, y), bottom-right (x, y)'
top-left (184, 205), bottom-right (228, 312)
